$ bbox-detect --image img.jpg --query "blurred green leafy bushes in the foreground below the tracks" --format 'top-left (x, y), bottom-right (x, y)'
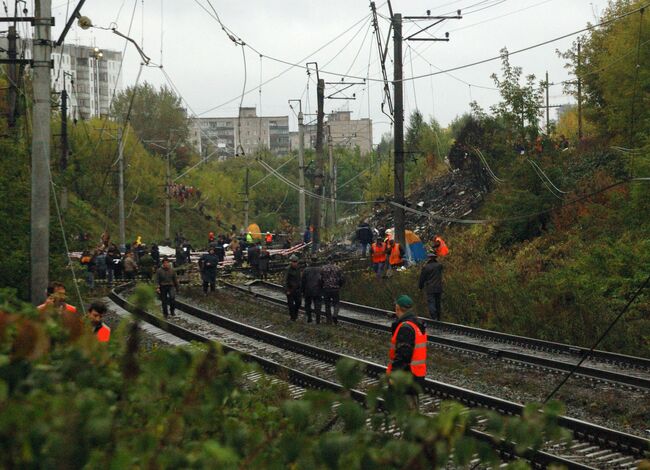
top-left (0, 288), bottom-right (567, 469)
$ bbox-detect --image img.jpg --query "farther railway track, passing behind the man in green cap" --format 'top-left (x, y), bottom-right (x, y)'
top-left (224, 281), bottom-right (650, 391)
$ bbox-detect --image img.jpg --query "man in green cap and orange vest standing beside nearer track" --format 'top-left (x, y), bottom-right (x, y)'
top-left (386, 295), bottom-right (427, 408)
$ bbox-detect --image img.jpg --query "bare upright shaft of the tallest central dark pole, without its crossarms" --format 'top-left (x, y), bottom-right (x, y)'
top-left (393, 13), bottom-right (406, 246)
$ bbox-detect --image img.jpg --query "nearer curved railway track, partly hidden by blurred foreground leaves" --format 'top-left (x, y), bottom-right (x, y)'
top-left (111, 284), bottom-right (650, 469)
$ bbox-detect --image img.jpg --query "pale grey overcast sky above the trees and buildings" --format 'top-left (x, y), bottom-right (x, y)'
top-left (49, 0), bottom-right (607, 142)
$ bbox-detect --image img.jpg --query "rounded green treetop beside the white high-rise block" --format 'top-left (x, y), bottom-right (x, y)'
top-left (111, 82), bottom-right (189, 154)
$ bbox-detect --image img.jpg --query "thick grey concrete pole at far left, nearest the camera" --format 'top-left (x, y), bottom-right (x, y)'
top-left (30, 0), bottom-right (52, 305)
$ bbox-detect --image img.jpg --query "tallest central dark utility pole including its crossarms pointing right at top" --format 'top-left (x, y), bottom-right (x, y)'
top-left (389, 8), bottom-right (462, 250)
